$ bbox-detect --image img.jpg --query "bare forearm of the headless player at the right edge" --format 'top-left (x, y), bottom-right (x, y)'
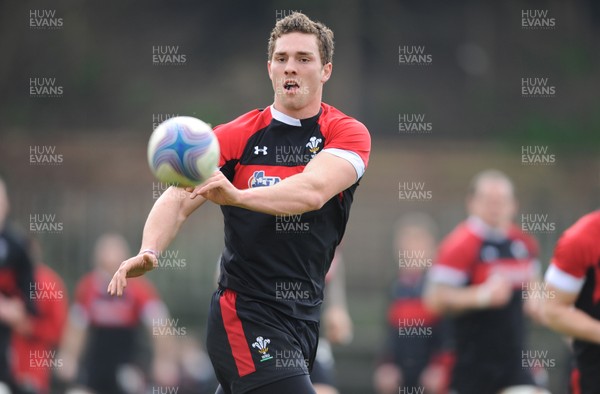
top-left (544, 305), bottom-right (600, 344)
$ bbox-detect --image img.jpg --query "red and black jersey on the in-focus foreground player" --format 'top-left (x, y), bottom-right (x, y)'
top-left (215, 104), bottom-right (371, 321)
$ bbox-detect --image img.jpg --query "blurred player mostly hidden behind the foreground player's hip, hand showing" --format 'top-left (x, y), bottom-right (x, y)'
top-left (310, 247), bottom-right (352, 394)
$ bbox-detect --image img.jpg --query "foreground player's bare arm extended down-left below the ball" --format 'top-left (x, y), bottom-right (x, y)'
top-left (107, 187), bottom-right (206, 296)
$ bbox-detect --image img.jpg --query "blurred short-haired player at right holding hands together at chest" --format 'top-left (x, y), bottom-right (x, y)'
top-left (426, 170), bottom-right (539, 394)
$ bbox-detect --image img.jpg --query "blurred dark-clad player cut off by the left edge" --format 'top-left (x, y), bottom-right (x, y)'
top-left (0, 178), bottom-right (35, 390)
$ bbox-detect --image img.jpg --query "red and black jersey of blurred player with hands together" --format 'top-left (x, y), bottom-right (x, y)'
top-left (429, 216), bottom-right (539, 386)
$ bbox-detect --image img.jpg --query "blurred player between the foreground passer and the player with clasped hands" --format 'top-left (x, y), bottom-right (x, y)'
top-left (373, 212), bottom-right (453, 394)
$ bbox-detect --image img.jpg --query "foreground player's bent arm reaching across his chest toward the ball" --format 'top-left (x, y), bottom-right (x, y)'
top-left (192, 152), bottom-right (357, 215)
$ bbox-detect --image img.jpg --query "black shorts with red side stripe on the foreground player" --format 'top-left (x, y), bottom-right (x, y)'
top-left (206, 289), bottom-right (319, 394)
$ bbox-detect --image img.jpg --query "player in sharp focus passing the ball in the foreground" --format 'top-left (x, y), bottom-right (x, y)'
top-left (108, 13), bottom-right (370, 394)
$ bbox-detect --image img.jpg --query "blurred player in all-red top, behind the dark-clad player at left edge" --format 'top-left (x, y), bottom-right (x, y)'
top-left (12, 238), bottom-right (69, 394)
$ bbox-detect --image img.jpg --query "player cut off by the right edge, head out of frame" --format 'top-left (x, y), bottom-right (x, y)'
top-left (543, 211), bottom-right (600, 394)
